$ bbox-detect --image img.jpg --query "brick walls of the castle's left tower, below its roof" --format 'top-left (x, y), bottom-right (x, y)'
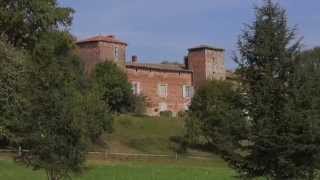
top-left (78, 42), bottom-right (126, 73)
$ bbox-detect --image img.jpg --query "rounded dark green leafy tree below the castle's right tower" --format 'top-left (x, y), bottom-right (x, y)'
top-left (182, 80), bottom-right (246, 155)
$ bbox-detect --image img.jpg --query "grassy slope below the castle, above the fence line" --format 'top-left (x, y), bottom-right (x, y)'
top-left (99, 115), bottom-right (184, 154)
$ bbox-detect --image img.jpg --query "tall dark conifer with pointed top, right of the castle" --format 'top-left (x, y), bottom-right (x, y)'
top-left (230, 0), bottom-right (320, 180)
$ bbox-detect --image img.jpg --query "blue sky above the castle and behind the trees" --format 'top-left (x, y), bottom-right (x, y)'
top-left (59, 0), bottom-right (320, 69)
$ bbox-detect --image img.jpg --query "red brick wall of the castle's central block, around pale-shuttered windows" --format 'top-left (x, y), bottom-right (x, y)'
top-left (127, 68), bottom-right (192, 115)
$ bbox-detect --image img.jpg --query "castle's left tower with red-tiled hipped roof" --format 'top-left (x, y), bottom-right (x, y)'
top-left (77, 35), bottom-right (127, 74)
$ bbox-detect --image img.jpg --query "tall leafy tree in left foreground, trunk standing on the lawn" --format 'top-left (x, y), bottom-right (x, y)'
top-left (11, 32), bottom-right (88, 180)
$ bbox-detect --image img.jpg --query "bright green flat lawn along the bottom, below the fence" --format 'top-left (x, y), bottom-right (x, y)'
top-left (0, 160), bottom-right (234, 180)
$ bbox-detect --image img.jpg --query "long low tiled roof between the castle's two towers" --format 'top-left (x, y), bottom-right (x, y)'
top-left (126, 63), bottom-right (192, 73)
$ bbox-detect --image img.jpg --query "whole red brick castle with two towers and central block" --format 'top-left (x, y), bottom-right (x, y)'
top-left (77, 36), bottom-right (229, 115)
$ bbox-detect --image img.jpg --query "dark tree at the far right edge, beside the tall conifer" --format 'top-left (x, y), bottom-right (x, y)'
top-left (285, 48), bottom-right (320, 180)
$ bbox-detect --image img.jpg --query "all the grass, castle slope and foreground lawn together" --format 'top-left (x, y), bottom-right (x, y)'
top-left (0, 115), bottom-right (235, 180)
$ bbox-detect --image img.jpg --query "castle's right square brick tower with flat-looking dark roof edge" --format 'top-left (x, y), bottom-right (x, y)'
top-left (187, 45), bottom-right (226, 88)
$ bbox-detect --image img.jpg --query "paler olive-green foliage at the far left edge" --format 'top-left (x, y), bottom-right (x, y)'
top-left (0, 39), bottom-right (25, 145)
